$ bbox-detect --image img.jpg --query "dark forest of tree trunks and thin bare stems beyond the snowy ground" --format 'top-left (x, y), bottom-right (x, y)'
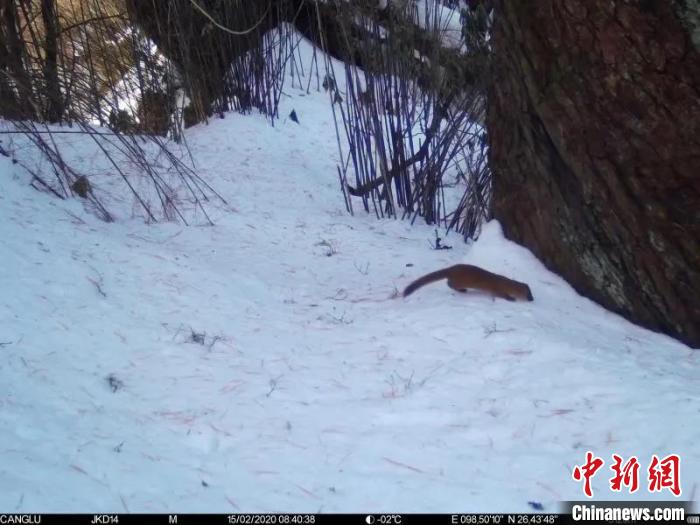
top-left (0, 0), bottom-right (700, 347)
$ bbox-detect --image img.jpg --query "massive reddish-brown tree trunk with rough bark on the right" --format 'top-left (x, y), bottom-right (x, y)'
top-left (487, 0), bottom-right (700, 347)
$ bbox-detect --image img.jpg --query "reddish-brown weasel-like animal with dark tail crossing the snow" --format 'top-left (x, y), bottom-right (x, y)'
top-left (403, 264), bottom-right (532, 301)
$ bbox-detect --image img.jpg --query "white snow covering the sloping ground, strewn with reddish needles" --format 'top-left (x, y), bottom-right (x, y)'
top-left (0, 39), bottom-right (700, 513)
